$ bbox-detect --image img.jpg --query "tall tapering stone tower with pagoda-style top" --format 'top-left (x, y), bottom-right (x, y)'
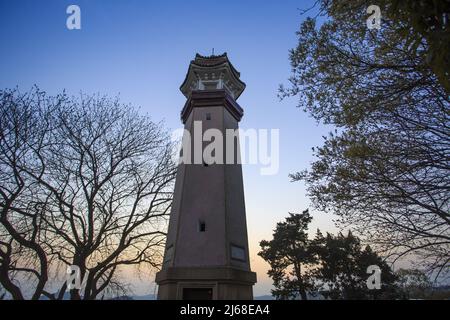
top-left (156, 53), bottom-right (256, 300)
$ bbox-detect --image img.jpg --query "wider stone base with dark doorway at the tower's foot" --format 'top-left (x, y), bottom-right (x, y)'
top-left (156, 267), bottom-right (256, 300)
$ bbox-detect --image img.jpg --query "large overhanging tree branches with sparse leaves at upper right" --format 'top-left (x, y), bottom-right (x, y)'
top-left (280, 0), bottom-right (450, 275)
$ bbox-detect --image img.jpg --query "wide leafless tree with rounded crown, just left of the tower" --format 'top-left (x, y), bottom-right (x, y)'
top-left (2, 86), bottom-right (175, 299)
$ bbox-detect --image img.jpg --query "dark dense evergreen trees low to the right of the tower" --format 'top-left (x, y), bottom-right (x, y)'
top-left (259, 210), bottom-right (396, 300)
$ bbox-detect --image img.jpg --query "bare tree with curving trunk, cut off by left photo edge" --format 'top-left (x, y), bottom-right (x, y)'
top-left (0, 88), bottom-right (60, 299)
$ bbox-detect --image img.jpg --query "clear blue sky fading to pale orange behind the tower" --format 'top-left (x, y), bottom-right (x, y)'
top-left (0, 0), bottom-right (334, 295)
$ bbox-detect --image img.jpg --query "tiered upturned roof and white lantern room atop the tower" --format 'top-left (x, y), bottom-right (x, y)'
top-left (180, 52), bottom-right (245, 99)
